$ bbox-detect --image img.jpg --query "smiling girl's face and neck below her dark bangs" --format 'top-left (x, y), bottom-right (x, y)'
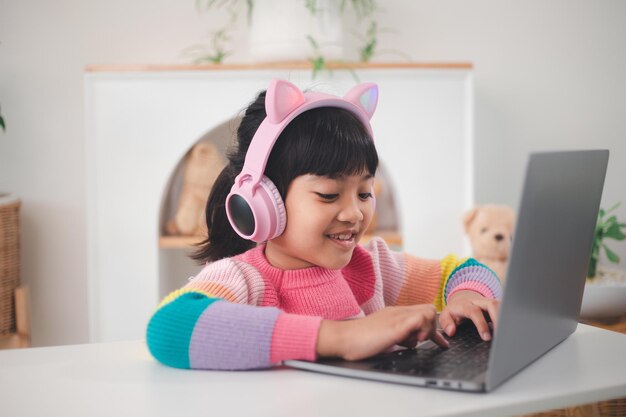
top-left (265, 174), bottom-right (374, 269)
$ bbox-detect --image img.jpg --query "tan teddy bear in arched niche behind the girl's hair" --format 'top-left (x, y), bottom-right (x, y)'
top-left (167, 142), bottom-right (226, 236)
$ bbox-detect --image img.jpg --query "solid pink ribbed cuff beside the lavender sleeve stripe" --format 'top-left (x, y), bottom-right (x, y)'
top-left (270, 313), bottom-right (322, 363)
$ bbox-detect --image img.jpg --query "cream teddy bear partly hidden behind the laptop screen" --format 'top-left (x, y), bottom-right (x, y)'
top-left (463, 204), bottom-right (515, 282)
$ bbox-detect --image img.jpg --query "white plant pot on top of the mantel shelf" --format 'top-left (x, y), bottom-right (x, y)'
top-left (249, 0), bottom-right (343, 62)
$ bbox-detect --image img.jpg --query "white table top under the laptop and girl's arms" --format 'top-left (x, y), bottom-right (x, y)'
top-left (0, 325), bottom-right (626, 417)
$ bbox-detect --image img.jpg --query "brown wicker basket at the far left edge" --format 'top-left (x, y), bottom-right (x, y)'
top-left (0, 193), bottom-right (20, 335)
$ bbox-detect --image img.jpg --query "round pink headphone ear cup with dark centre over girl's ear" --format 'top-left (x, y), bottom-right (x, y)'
top-left (226, 176), bottom-right (287, 243)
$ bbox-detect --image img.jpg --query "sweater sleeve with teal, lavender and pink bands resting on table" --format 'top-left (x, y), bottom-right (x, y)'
top-left (146, 259), bottom-right (321, 370)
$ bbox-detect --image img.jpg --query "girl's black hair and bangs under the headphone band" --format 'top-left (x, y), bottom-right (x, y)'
top-left (265, 107), bottom-right (378, 198)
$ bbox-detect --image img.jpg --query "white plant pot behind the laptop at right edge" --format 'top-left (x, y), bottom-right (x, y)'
top-left (580, 267), bottom-right (626, 320)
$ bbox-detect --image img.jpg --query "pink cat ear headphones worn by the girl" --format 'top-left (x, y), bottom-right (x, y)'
top-left (226, 80), bottom-right (378, 242)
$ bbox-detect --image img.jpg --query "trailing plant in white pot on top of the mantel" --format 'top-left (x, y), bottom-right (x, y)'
top-left (186, 0), bottom-right (379, 76)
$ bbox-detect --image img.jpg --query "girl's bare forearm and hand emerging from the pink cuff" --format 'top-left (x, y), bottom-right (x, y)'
top-left (317, 304), bottom-right (449, 360)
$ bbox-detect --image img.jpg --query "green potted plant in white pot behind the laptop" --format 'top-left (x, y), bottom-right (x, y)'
top-left (581, 203), bottom-right (626, 320)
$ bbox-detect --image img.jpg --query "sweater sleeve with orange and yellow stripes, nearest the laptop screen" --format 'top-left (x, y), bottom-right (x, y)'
top-left (366, 238), bottom-right (502, 311)
